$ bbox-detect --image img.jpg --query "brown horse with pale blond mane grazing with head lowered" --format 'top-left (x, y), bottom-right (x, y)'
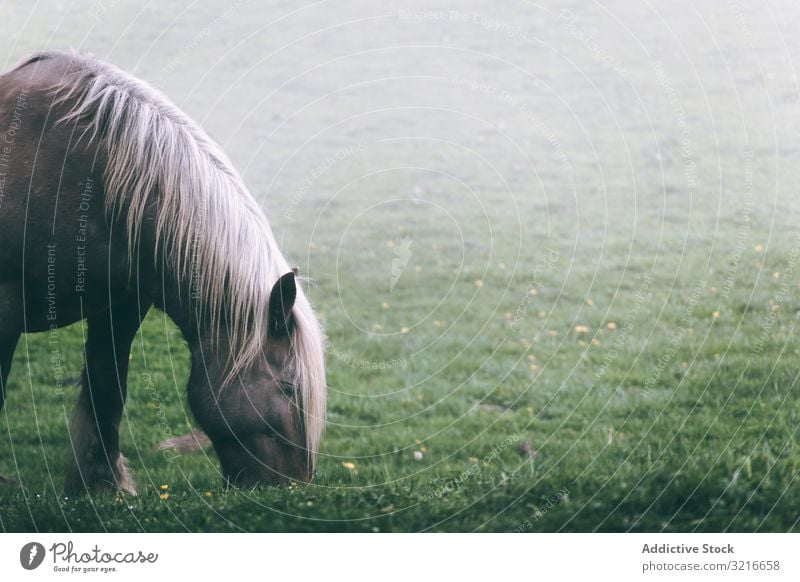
top-left (0, 51), bottom-right (326, 495)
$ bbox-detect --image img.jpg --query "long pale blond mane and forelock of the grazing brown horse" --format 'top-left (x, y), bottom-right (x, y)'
top-left (17, 52), bottom-right (326, 460)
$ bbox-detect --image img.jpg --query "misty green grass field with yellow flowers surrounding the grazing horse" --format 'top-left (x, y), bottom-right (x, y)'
top-left (0, 2), bottom-right (800, 532)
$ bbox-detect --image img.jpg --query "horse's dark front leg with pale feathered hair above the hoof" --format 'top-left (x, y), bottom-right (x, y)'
top-left (65, 300), bottom-right (150, 495)
